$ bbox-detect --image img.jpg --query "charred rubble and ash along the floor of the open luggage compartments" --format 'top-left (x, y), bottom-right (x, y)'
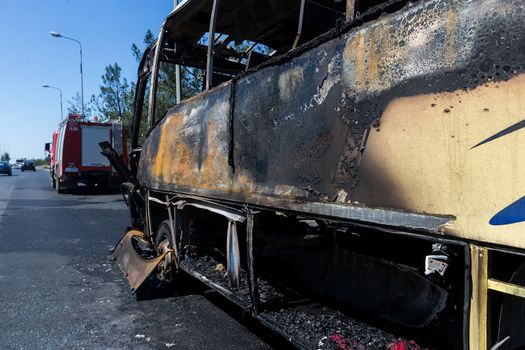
top-left (181, 256), bottom-right (422, 350)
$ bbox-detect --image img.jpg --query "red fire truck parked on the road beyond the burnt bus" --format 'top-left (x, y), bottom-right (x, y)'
top-left (46, 114), bottom-right (127, 193)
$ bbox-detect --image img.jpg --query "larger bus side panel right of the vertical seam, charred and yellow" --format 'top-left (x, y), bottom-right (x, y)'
top-left (234, 1), bottom-right (525, 248)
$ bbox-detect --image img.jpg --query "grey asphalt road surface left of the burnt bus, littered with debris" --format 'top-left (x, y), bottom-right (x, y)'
top-left (0, 169), bottom-right (270, 349)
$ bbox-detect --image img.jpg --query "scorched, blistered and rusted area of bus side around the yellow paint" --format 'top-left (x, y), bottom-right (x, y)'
top-left (141, 0), bottom-right (525, 243)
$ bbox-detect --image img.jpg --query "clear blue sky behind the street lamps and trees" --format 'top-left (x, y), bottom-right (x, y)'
top-left (0, 0), bottom-right (173, 159)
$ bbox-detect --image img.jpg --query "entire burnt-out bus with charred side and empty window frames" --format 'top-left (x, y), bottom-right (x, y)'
top-left (104, 0), bottom-right (525, 349)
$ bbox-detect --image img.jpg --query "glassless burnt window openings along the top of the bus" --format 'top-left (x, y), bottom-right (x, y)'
top-left (150, 0), bottom-right (410, 120)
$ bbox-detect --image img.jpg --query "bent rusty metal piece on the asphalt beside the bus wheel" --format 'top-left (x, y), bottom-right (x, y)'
top-left (111, 230), bottom-right (168, 292)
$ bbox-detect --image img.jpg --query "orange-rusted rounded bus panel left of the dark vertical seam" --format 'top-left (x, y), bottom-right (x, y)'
top-left (138, 84), bottom-right (232, 194)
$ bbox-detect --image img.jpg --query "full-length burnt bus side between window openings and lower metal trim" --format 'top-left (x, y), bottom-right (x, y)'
top-left (139, 0), bottom-right (525, 248)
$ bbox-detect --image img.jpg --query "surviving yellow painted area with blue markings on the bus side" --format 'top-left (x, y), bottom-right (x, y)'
top-left (351, 75), bottom-right (525, 248)
